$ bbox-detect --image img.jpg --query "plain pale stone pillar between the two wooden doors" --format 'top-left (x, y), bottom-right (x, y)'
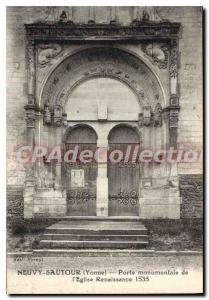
top-left (97, 139), bottom-right (108, 217)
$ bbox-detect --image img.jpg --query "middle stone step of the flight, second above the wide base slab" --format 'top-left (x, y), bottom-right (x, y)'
top-left (41, 233), bottom-right (148, 241)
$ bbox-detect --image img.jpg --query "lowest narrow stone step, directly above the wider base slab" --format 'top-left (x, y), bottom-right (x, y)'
top-left (40, 240), bottom-right (148, 249)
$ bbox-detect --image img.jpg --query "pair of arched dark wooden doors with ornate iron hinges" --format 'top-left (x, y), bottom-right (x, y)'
top-left (62, 126), bottom-right (140, 216)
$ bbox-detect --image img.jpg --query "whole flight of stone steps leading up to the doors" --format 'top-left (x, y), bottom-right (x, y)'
top-left (37, 217), bottom-right (148, 249)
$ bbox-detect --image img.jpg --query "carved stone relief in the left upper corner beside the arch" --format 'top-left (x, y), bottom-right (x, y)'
top-left (38, 44), bottom-right (62, 67)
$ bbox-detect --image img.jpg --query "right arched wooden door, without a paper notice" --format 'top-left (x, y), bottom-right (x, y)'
top-left (108, 128), bottom-right (140, 216)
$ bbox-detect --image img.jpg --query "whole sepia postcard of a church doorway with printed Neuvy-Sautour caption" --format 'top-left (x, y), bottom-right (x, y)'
top-left (7, 6), bottom-right (204, 294)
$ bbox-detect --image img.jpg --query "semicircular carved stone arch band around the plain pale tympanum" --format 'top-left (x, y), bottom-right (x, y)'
top-left (42, 47), bottom-right (163, 111)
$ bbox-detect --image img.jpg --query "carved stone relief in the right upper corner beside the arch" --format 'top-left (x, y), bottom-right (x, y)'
top-left (142, 43), bottom-right (168, 69)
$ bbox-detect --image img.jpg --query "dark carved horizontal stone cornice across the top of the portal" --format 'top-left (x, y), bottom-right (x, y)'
top-left (25, 21), bottom-right (180, 41)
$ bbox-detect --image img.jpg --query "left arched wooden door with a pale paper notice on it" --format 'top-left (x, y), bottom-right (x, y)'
top-left (64, 127), bottom-right (97, 216)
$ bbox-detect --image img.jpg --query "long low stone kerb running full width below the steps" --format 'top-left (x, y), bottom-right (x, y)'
top-left (7, 249), bottom-right (203, 257)
